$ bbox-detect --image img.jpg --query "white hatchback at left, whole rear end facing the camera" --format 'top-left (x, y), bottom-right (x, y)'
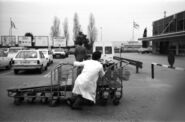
top-left (12, 50), bottom-right (47, 74)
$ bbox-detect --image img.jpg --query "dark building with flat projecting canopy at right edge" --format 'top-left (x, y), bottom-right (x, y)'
top-left (139, 11), bottom-right (185, 55)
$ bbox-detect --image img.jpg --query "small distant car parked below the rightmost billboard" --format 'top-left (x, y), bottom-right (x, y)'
top-left (53, 48), bottom-right (67, 58)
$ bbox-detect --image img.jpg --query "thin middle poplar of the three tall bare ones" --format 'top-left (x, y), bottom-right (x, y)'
top-left (73, 13), bottom-right (80, 42)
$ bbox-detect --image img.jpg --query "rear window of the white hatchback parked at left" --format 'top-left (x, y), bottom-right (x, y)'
top-left (16, 51), bottom-right (37, 58)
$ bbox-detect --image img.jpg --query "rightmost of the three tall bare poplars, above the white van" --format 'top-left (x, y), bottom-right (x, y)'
top-left (88, 13), bottom-right (97, 50)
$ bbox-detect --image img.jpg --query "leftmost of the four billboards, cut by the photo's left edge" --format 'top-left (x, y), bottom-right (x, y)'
top-left (0, 36), bottom-right (16, 46)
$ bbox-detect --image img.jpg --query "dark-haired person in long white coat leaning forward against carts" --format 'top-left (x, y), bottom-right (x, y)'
top-left (67, 51), bottom-right (105, 109)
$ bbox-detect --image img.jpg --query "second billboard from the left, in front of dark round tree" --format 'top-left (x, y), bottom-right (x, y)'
top-left (18, 36), bottom-right (31, 46)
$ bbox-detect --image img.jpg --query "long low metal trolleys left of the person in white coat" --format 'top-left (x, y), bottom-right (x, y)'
top-left (7, 63), bottom-right (76, 106)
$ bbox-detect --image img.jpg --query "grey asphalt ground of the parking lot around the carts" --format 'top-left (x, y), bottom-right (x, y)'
top-left (0, 53), bottom-right (185, 121)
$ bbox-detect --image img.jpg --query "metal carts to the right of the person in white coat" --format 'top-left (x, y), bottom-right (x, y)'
top-left (96, 60), bottom-right (130, 105)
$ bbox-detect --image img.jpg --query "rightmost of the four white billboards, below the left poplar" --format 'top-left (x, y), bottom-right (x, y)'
top-left (53, 36), bottom-right (66, 47)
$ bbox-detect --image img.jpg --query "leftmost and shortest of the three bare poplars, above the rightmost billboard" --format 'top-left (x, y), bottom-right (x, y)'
top-left (50, 16), bottom-right (60, 37)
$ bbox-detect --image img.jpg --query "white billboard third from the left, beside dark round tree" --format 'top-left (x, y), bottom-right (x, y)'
top-left (34, 36), bottom-right (49, 46)
